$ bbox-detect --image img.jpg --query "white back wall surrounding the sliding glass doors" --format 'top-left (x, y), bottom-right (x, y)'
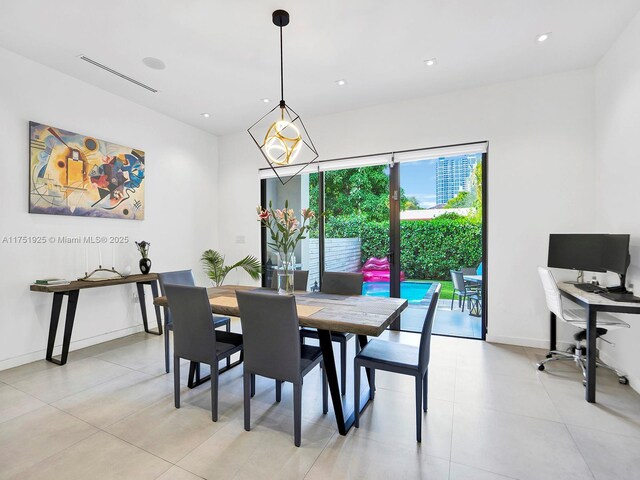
top-left (219, 69), bottom-right (595, 347)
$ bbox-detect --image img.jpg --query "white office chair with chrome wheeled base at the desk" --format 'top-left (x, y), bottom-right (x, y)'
top-left (537, 267), bottom-right (629, 385)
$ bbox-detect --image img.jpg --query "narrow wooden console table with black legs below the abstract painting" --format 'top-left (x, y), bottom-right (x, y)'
top-left (30, 273), bottom-right (162, 365)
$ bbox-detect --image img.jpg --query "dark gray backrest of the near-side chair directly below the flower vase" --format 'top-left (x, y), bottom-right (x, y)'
top-left (236, 291), bottom-right (302, 385)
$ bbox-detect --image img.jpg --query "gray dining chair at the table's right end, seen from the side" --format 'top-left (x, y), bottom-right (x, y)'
top-left (353, 283), bottom-right (442, 442)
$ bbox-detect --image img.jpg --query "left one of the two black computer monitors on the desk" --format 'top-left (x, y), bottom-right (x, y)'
top-left (547, 233), bottom-right (606, 272)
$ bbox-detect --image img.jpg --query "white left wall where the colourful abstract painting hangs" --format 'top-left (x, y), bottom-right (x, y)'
top-left (0, 49), bottom-right (218, 369)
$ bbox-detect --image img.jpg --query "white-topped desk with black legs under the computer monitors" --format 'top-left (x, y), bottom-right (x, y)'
top-left (550, 283), bottom-right (640, 403)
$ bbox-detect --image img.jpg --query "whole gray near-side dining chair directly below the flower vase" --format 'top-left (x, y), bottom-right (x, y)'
top-left (236, 291), bottom-right (329, 447)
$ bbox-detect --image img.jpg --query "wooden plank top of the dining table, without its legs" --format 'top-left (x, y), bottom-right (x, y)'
top-left (154, 286), bottom-right (408, 337)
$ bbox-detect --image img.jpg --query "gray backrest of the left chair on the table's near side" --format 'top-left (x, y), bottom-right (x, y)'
top-left (165, 283), bottom-right (216, 364)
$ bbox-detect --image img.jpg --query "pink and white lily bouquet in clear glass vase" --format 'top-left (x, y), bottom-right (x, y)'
top-left (257, 200), bottom-right (315, 295)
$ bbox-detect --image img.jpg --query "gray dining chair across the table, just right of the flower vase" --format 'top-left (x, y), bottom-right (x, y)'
top-left (300, 272), bottom-right (363, 395)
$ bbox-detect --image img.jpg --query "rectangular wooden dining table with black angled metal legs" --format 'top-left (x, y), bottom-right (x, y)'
top-left (154, 285), bottom-right (408, 435)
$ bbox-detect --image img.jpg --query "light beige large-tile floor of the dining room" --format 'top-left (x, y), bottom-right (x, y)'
top-left (0, 320), bottom-right (640, 480)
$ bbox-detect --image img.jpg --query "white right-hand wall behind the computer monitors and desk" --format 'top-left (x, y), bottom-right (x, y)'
top-left (594, 14), bottom-right (640, 389)
